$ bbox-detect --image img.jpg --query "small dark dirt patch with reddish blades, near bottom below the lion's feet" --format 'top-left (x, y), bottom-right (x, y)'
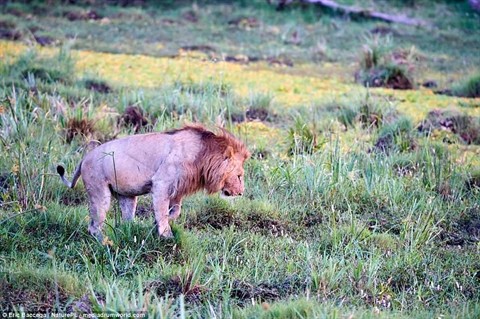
top-left (145, 273), bottom-right (207, 303)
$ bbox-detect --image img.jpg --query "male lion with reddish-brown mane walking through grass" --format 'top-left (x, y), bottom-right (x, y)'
top-left (57, 125), bottom-right (250, 240)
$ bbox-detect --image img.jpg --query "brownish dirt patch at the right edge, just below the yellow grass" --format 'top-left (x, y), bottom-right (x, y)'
top-left (418, 110), bottom-right (480, 145)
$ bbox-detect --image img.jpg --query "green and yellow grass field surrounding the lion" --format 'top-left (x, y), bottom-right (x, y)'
top-left (0, 0), bottom-right (480, 318)
